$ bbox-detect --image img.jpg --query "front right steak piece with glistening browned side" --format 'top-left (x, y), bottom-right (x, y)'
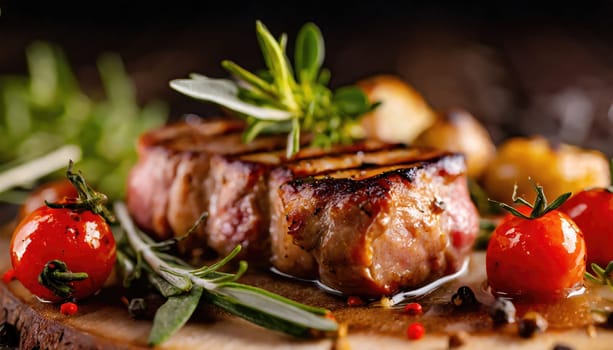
top-left (271, 154), bottom-right (478, 296)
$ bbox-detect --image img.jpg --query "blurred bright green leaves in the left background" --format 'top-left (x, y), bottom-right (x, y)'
top-left (0, 42), bottom-right (168, 198)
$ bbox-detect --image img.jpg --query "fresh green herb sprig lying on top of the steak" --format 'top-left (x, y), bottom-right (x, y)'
top-left (170, 21), bottom-right (377, 158)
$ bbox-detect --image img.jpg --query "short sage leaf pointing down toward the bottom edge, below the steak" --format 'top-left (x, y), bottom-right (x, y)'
top-left (148, 286), bottom-right (203, 346)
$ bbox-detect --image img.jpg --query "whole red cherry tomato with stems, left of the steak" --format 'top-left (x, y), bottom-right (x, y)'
top-left (10, 162), bottom-right (116, 302)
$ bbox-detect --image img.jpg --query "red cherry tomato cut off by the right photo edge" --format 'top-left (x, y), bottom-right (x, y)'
top-left (560, 188), bottom-right (613, 267)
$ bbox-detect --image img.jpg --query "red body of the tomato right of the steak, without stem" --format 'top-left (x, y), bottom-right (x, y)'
top-left (486, 210), bottom-right (586, 300)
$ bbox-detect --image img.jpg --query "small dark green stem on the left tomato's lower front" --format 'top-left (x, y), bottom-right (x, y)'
top-left (38, 260), bottom-right (89, 298)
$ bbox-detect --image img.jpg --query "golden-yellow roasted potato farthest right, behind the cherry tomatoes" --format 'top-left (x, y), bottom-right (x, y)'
top-left (483, 136), bottom-right (611, 203)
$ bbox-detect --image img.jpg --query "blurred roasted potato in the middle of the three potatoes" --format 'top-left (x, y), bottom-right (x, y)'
top-left (413, 109), bottom-right (496, 178)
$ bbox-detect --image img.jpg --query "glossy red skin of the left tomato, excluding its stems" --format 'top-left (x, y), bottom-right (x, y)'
top-left (10, 206), bottom-right (116, 302)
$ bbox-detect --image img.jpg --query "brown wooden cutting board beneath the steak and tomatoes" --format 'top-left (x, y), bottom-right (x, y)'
top-left (0, 223), bottom-right (613, 350)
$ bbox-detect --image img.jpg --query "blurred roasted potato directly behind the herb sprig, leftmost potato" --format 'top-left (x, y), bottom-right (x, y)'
top-left (357, 75), bottom-right (436, 143)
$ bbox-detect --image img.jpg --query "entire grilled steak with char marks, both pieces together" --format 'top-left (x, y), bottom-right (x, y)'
top-left (127, 120), bottom-right (478, 296)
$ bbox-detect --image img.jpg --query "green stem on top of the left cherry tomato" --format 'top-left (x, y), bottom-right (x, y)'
top-left (45, 160), bottom-right (115, 223)
